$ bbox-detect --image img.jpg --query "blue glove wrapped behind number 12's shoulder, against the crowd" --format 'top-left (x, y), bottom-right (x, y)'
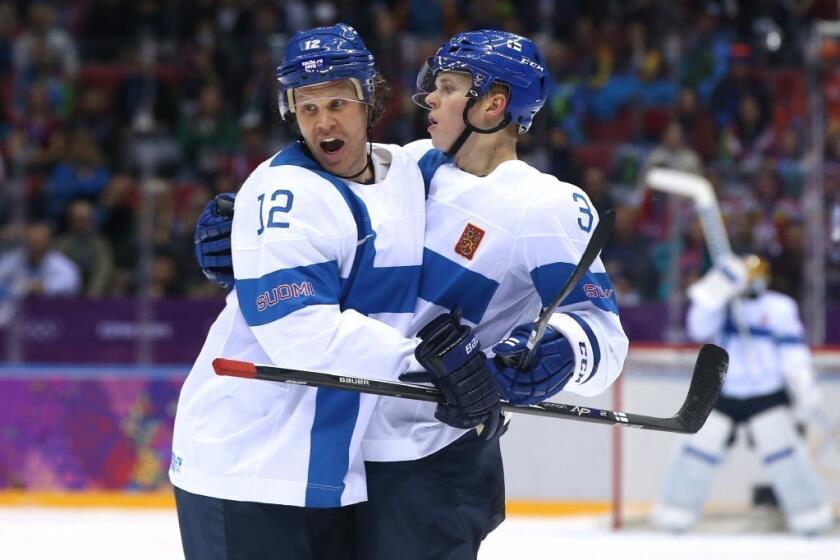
top-left (193, 193), bottom-right (236, 289)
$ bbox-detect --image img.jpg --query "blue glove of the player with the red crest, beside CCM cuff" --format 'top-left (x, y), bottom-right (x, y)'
top-left (491, 323), bottom-right (575, 404)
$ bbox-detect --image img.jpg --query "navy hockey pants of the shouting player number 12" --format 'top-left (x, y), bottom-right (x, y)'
top-left (175, 488), bottom-right (356, 560)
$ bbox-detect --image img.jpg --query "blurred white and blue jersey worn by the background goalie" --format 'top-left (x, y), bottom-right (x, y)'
top-left (687, 290), bottom-right (812, 399)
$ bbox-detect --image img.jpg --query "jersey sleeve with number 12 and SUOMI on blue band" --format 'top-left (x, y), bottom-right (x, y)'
top-left (231, 166), bottom-right (422, 378)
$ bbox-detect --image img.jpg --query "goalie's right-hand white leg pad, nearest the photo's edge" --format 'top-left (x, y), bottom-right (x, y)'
top-left (749, 406), bottom-right (833, 534)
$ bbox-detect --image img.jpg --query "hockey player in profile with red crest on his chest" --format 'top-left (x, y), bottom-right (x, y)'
top-left (197, 30), bottom-right (627, 560)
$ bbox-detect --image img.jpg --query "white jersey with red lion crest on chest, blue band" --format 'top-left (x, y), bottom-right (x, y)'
top-left (364, 140), bottom-right (628, 461)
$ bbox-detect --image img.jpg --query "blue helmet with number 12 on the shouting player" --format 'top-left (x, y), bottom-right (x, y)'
top-left (277, 23), bottom-right (376, 120)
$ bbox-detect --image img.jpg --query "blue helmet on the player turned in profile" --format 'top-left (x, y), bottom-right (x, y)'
top-left (413, 29), bottom-right (550, 134)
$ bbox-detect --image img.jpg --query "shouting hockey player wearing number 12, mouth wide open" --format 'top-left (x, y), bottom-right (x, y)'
top-left (170, 24), bottom-right (500, 560)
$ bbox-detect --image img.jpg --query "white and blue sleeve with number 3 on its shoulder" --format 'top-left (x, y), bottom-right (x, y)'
top-left (515, 182), bottom-right (629, 396)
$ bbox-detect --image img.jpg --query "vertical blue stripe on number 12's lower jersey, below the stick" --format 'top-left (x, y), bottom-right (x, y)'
top-left (306, 389), bottom-right (359, 507)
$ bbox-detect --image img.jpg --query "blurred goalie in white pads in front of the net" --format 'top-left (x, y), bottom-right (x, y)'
top-left (652, 255), bottom-right (833, 535)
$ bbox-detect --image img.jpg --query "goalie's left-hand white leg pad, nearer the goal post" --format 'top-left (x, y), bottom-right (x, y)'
top-left (651, 410), bottom-right (734, 532)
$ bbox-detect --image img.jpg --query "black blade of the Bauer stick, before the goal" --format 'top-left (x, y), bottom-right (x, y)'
top-left (676, 344), bottom-right (729, 434)
